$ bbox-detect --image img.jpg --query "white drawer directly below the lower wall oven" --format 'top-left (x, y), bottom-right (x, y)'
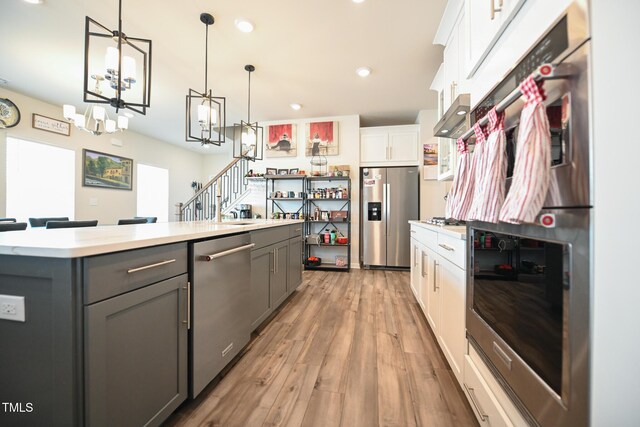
top-left (463, 356), bottom-right (513, 427)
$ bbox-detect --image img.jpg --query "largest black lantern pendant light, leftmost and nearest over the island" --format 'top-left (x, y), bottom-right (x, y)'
top-left (83, 0), bottom-right (151, 114)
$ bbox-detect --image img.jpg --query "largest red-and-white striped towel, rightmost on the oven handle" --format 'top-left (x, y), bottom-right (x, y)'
top-left (500, 77), bottom-right (551, 224)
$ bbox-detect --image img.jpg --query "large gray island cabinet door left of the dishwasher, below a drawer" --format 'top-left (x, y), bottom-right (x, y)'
top-left (85, 274), bottom-right (187, 427)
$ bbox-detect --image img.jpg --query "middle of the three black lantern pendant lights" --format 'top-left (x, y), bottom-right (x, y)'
top-left (186, 13), bottom-right (227, 145)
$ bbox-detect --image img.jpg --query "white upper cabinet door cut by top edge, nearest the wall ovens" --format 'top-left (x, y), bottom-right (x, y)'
top-left (464, 0), bottom-right (526, 78)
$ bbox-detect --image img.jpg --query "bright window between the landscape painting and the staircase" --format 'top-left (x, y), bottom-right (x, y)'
top-left (137, 163), bottom-right (169, 222)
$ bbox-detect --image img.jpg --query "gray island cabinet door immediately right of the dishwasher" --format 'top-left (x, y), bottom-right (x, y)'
top-left (249, 246), bottom-right (274, 331)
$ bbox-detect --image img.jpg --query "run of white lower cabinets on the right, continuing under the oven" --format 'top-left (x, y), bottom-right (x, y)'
top-left (411, 222), bottom-right (528, 427)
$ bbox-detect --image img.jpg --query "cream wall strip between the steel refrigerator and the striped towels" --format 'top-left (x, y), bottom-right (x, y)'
top-left (418, 110), bottom-right (452, 219)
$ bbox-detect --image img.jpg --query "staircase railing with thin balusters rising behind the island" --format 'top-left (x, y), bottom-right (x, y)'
top-left (176, 158), bottom-right (254, 221)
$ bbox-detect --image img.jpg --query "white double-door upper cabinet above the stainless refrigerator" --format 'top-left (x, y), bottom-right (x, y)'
top-left (360, 125), bottom-right (420, 166)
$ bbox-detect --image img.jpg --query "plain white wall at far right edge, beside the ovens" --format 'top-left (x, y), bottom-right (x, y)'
top-left (591, 0), bottom-right (640, 426)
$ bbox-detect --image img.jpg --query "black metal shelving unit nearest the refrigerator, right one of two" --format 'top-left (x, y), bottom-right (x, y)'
top-left (304, 176), bottom-right (351, 271)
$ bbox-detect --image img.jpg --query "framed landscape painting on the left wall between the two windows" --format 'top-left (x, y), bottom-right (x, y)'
top-left (82, 149), bottom-right (133, 190)
